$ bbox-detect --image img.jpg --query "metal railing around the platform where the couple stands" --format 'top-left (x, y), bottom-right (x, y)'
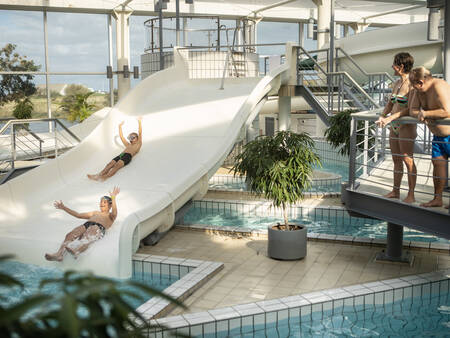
top-left (349, 111), bottom-right (450, 211)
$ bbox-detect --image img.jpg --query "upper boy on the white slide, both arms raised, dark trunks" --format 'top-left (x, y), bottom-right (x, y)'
top-left (87, 117), bottom-right (142, 181)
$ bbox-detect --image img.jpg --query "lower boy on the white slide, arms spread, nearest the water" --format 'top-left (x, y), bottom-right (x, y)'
top-left (45, 187), bottom-right (120, 262)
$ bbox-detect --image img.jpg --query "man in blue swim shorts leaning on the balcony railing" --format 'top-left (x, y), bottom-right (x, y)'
top-left (409, 67), bottom-right (450, 207)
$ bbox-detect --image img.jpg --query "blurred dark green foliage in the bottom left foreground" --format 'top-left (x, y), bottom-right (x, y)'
top-left (0, 256), bottom-right (182, 337)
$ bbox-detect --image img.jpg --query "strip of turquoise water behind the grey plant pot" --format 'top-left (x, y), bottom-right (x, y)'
top-left (184, 206), bottom-right (450, 243)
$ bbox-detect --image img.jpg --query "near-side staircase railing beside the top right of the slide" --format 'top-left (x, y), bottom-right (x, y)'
top-left (297, 46), bottom-right (379, 115)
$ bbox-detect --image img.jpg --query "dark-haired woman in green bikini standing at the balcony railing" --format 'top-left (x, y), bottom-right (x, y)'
top-left (377, 53), bottom-right (417, 203)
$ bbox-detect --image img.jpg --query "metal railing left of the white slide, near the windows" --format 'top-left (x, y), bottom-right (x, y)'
top-left (0, 118), bottom-right (80, 172)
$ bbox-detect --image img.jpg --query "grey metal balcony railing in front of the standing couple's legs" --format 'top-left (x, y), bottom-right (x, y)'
top-left (349, 111), bottom-right (450, 213)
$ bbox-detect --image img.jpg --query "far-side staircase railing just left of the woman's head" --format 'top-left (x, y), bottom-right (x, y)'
top-left (335, 47), bottom-right (395, 105)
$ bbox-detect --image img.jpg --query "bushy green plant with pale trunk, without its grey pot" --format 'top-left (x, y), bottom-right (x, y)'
top-left (232, 131), bottom-right (321, 229)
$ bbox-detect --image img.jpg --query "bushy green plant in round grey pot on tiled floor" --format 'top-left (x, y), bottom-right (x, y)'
top-left (232, 131), bottom-right (320, 260)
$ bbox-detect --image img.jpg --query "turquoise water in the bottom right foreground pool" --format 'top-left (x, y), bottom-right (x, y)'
top-left (214, 292), bottom-right (450, 338)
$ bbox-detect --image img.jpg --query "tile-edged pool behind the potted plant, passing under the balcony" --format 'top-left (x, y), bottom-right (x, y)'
top-left (183, 200), bottom-right (450, 243)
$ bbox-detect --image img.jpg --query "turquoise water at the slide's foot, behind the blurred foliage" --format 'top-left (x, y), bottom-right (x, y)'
top-left (0, 261), bottom-right (178, 308)
